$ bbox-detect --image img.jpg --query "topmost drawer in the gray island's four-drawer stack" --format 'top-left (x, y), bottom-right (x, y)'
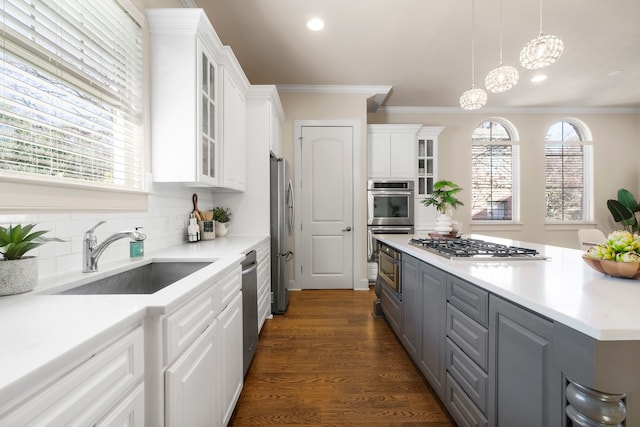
top-left (447, 274), bottom-right (489, 326)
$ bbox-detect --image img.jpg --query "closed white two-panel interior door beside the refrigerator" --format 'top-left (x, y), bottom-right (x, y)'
top-left (297, 126), bottom-right (354, 289)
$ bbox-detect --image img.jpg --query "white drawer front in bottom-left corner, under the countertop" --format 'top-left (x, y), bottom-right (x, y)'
top-left (0, 325), bottom-right (144, 426)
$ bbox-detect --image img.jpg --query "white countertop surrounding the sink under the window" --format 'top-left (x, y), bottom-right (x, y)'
top-left (0, 236), bottom-right (268, 406)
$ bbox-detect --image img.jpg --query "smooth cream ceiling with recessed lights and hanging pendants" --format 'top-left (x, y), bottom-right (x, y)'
top-left (164, 0), bottom-right (640, 109)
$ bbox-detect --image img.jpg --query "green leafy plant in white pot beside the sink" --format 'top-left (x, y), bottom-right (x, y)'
top-left (0, 224), bottom-right (63, 296)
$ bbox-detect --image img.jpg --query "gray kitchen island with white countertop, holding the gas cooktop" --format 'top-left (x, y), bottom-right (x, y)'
top-left (376, 235), bottom-right (640, 426)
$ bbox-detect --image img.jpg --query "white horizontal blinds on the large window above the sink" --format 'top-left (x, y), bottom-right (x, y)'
top-left (0, 0), bottom-right (144, 190)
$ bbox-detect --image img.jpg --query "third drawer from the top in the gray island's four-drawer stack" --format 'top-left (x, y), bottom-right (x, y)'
top-left (447, 339), bottom-right (489, 414)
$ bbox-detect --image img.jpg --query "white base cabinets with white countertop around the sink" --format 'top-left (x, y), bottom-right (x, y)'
top-left (0, 236), bottom-right (269, 426)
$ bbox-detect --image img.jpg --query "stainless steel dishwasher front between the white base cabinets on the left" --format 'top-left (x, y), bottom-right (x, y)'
top-left (242, 251), bottom-right (258, 375)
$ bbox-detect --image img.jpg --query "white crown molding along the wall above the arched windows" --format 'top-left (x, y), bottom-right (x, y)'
top-left (377, 107), bottom-right (640, 115)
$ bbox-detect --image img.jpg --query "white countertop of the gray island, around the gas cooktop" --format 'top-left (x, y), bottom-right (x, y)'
top-left (375, 234), bottom-right (640, 341)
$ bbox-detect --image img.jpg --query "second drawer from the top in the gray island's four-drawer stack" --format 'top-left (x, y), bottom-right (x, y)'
top-left (447, 304), bottom-right (489, 372)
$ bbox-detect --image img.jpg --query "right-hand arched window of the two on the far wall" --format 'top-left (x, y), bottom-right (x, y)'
top-left (545, 119), bottom-right (593, 222)
